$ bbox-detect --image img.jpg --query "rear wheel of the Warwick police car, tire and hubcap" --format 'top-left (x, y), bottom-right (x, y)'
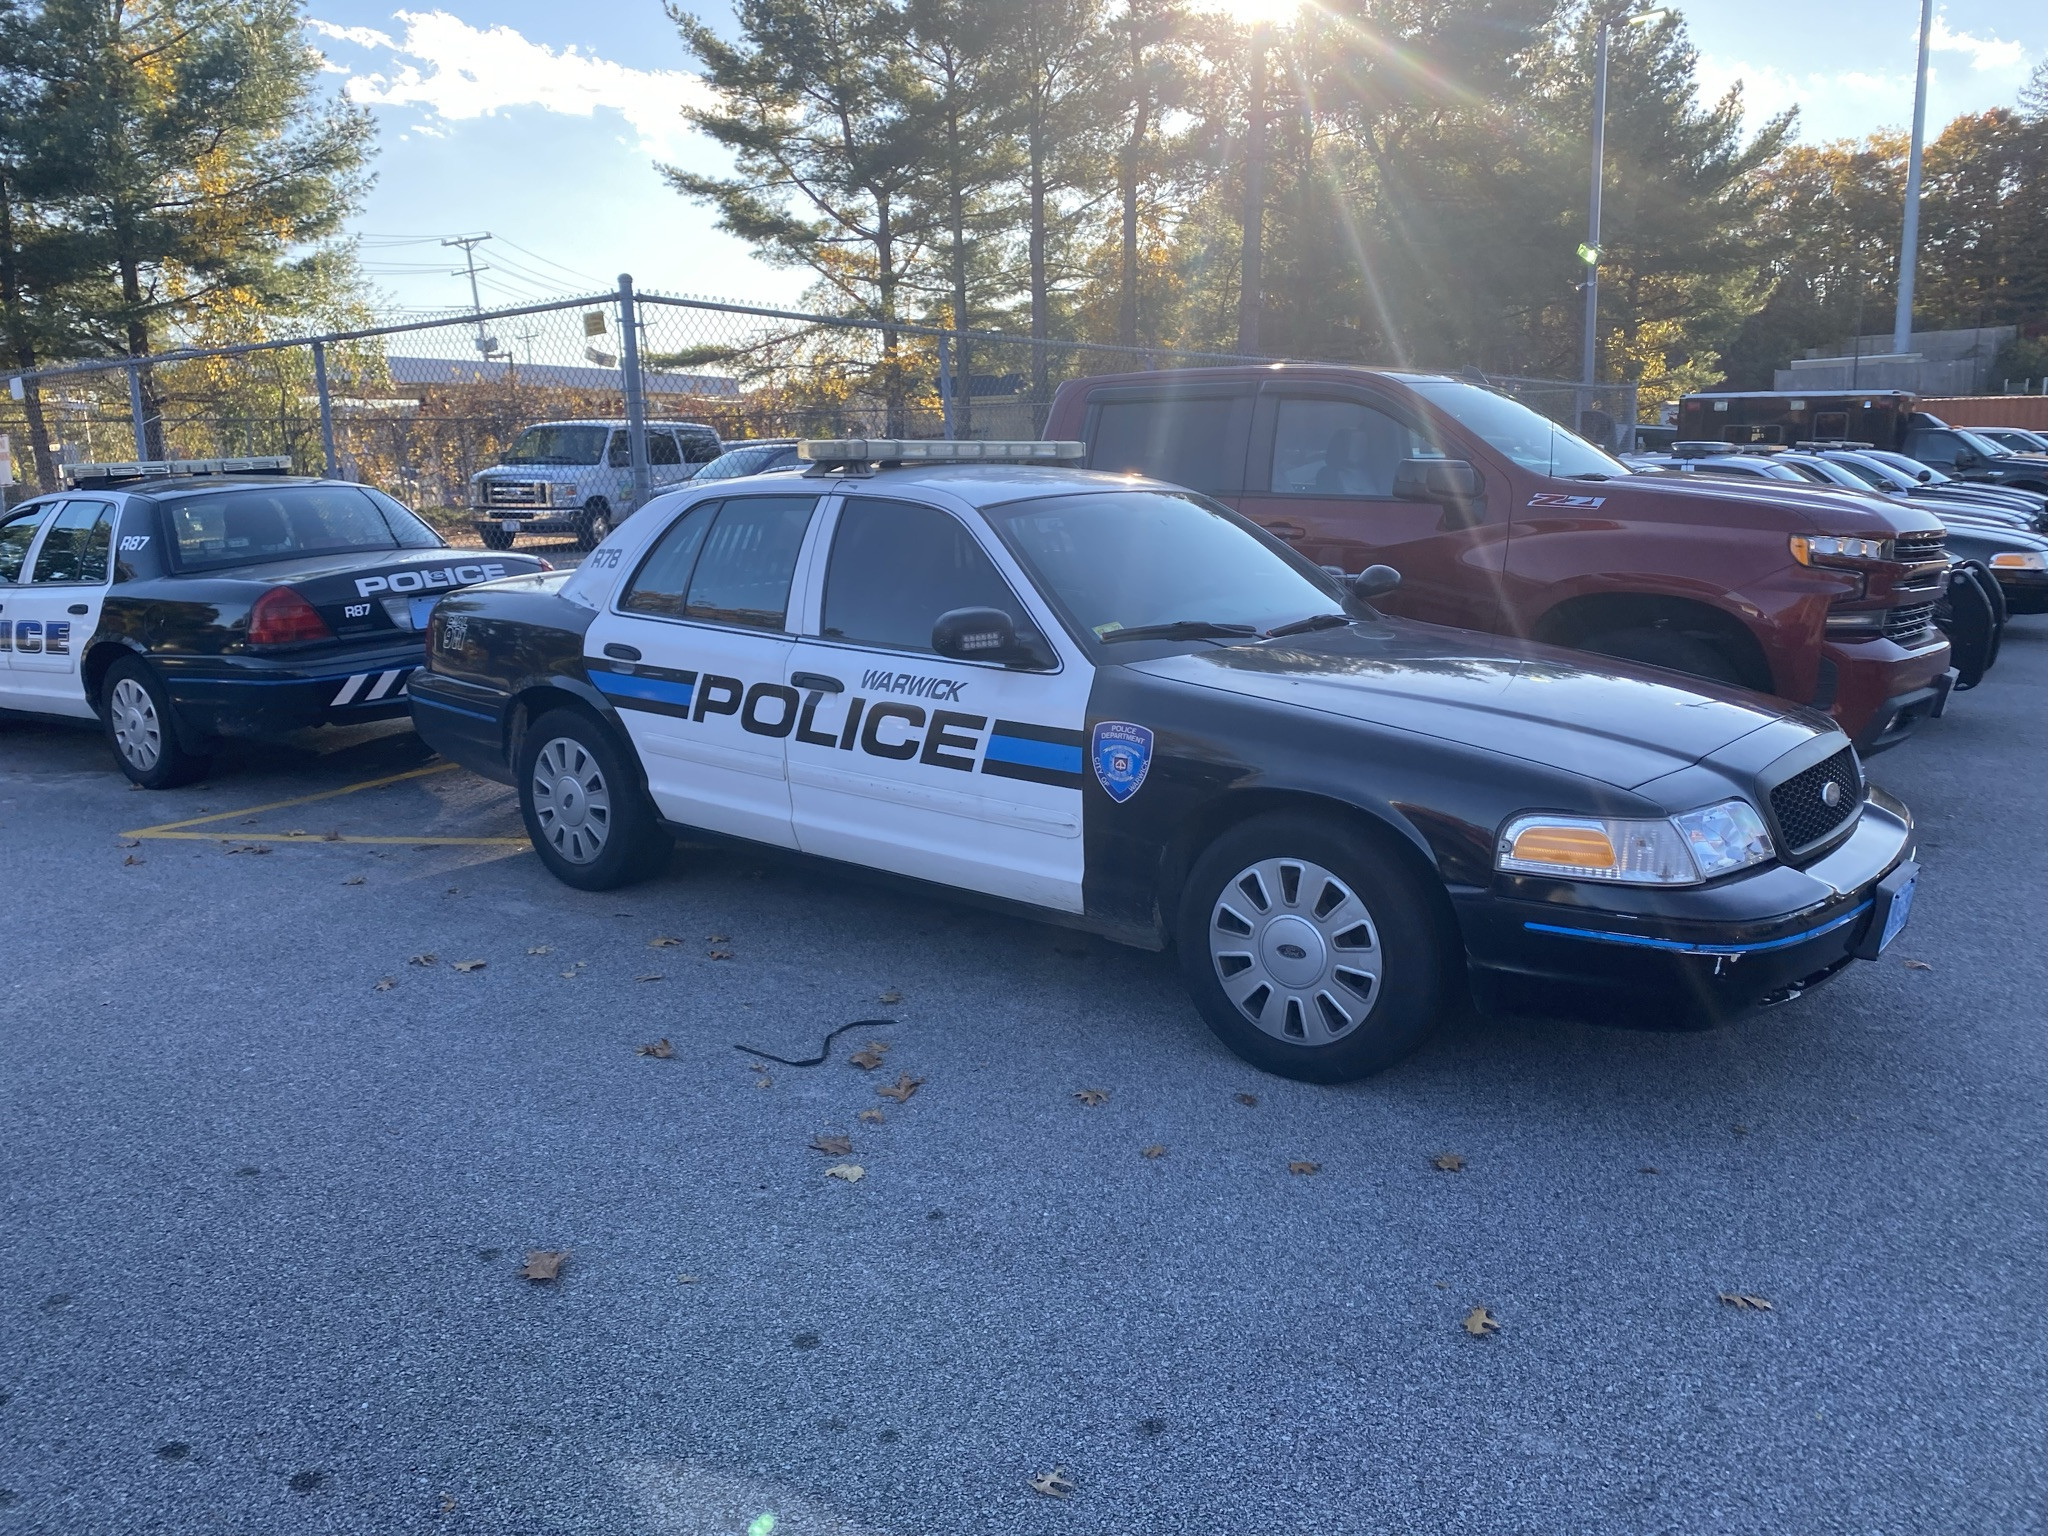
top-left (518, 709), bottom-right (674, 891)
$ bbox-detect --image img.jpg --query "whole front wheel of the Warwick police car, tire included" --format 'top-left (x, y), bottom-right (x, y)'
top-left (1176, 813), bottom-right (1460, 1083)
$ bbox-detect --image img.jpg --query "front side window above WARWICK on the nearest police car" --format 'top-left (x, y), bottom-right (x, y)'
top-left (823, 498), bottom-right (1032, 653)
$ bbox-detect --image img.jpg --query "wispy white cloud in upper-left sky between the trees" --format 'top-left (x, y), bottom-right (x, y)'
top-left (307, 10), bottom-right (705, 158)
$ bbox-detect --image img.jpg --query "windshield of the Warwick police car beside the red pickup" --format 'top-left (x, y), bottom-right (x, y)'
top-left (985, 489), bottom-right (1343, 641)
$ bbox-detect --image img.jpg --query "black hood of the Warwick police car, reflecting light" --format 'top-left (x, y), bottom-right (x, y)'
top-left (1128, 618), bottom-right (1835, 788)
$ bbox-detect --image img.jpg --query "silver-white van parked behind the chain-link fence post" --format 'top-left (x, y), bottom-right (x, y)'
top-left (469, 422), bottom-right (723, 549)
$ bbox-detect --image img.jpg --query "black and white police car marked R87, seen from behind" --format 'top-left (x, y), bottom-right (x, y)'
top-left (0, 459), bottom-right (549, 788)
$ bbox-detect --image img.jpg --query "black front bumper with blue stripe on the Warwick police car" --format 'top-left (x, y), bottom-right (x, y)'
top-left (1452, 788), bottom-right (1913, 1028)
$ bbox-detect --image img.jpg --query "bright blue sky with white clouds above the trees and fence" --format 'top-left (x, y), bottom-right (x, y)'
top-left (309, 0), bottom-right (2048, 315)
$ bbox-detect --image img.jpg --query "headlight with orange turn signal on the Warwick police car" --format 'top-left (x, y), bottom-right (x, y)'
top-left (1493, 801), bottom-right (1776, 885)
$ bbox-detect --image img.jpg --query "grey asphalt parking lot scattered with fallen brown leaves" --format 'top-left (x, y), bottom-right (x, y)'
top-left (0, 621), bottom-right (2048, 1536)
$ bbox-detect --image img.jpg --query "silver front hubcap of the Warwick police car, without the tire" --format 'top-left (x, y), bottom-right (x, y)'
top-left (1208, 858), bottom-right (1380, 1044)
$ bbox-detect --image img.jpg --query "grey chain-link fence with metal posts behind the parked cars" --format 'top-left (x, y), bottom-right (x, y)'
top-left (0, 279), bottom-right (1636, 528)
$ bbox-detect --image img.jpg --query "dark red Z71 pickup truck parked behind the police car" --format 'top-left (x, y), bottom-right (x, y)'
top-left (1047, 372), bottom-right (1954, 754)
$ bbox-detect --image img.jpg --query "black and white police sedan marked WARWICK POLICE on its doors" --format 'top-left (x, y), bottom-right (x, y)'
top-left (412, 440), bottom-right (1917, 1081)
